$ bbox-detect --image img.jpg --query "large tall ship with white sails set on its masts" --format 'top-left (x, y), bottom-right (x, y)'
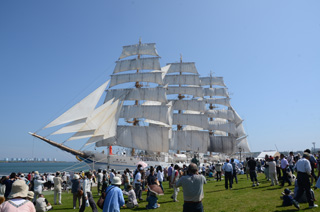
top-left (30, 41), bottom-right (249, 170)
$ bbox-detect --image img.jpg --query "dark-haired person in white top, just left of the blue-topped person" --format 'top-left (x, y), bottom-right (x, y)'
top-left (79, 172), bottom-right (98, 212)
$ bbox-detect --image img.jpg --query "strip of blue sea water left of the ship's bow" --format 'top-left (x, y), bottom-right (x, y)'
top-left (0, 162), bottom-right (90, 176)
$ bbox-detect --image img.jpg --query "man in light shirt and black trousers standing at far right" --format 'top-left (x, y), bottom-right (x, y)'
top-left (294, 152), bottom-right (318, 208)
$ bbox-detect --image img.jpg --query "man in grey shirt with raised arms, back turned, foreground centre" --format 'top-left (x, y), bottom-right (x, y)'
top-left (175, 163), bottom-right (207, 212)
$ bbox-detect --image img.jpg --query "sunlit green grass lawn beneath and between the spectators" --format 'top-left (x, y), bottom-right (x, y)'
top-left (45, 174), bottom-right (320, 212)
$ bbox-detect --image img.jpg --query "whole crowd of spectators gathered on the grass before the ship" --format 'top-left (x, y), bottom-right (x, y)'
top-left (0, 149), bottom-right (320, 212)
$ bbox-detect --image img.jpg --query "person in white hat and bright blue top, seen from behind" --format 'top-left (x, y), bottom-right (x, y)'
top-left (103, 177), bottom-right (125, 212)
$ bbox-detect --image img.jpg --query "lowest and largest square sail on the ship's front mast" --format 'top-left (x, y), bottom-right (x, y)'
top-left (96, 126), bottom-right (169, 152)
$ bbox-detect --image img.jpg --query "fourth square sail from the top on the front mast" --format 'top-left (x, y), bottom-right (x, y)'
top-left (105, 87), bottom-right (167, 102)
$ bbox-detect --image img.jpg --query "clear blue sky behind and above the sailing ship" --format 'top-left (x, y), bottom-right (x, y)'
top-left (0, 0), bottom-right (320, 160)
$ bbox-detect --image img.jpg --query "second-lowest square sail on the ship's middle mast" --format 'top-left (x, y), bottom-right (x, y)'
top-left (172, 114), bottom-right (208, 129)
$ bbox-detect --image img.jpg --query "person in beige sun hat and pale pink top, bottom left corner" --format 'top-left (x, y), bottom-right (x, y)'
top-left (0, 180), bottom-right (36, 212)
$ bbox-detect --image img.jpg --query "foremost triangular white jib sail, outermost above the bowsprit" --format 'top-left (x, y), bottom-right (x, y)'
top-left (44, 80), bottom-right (109, 128)
